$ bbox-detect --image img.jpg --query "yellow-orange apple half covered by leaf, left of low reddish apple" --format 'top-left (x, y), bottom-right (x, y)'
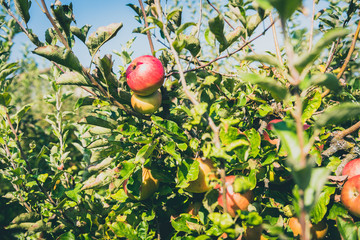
top-left (185, 158), bottom-right (215, 193)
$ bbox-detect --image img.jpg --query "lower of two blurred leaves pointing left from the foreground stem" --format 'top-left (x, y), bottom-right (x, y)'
top-left (240, 73), bottom-right (289, 100)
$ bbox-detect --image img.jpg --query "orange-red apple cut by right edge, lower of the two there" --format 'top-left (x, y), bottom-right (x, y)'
top-left (341, 175), bottom-right (360, 217)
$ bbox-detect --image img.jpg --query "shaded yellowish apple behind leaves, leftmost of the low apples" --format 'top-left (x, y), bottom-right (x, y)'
top-left (124, 168), bottom-right (159, 201)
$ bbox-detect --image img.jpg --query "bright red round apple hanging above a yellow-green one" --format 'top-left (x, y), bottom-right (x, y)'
top-left (126, 55), bottom-right (165, 96)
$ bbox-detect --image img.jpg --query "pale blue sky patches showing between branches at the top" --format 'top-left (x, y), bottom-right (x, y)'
top-left (11, 0), bottom-right (321, 70)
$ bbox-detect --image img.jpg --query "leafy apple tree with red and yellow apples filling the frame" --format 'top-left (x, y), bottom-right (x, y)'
top-left (0, 0), bottom-right (360, 240)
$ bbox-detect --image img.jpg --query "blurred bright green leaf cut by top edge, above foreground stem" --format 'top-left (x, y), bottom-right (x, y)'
top-left (256, 0), bottom-right (302, 20)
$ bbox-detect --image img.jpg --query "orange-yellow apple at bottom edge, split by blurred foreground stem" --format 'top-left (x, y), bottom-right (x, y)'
top-left (288, 217), bottom-right (328, 239)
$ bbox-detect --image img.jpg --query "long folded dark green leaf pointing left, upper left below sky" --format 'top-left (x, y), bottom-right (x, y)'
top-left (33, 45), bottom-right (82, 72)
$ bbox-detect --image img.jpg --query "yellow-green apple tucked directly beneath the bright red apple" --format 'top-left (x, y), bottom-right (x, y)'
top-left (131, 91), bottom-right (162, 114)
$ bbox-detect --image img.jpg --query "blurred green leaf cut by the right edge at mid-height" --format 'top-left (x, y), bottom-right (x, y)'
top-left (315, 103), bottom-right (360, 128)
